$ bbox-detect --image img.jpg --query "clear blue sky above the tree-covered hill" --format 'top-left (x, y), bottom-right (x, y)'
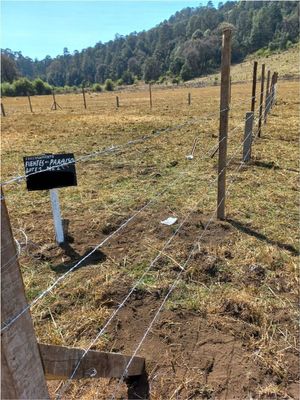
top-left (1, 0), bottom-right (217, 59)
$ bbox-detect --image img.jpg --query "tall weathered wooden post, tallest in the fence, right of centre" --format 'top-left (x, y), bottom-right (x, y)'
top-left (217, 27), bottom-right (231, 219)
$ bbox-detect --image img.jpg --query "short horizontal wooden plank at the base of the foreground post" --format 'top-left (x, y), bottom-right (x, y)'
top-left (39, 343), bottom-right (145, 380)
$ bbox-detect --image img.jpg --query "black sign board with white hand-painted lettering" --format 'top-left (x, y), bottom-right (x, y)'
top-left (23, 153), bottom-right (77, 190)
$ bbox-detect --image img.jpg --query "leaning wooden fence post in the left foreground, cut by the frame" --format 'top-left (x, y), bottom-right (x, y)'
top-left (1, 192), bottom-right (49, 399)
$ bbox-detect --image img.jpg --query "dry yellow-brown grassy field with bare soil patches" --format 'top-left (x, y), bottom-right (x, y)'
top-left (2, 54), bottom-right (299, 400)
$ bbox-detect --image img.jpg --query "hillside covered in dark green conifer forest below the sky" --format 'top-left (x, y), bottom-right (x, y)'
top-left (1, 1), bottom-right (299, 86)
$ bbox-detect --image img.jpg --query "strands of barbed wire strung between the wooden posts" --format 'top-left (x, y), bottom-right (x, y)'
top-left (1, 73), bottom-right (280, 399)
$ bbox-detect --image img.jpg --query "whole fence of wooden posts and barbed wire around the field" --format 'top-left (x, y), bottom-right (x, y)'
top-left (1, 28), bottom-right (278, 399)
